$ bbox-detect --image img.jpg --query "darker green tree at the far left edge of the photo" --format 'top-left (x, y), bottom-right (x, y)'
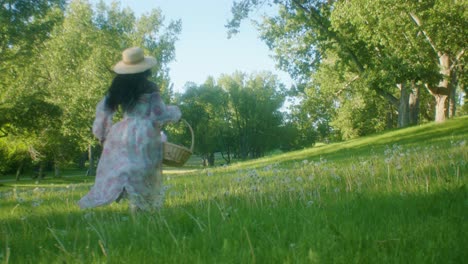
top-left (0, 0), bottom-right (65, 137)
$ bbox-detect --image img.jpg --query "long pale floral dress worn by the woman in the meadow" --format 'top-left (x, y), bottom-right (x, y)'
top-left (78, 92), bottom-right (181, 210)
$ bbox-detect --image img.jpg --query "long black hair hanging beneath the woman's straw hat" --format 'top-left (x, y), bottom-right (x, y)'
top-left (106, 70), bottom-right (155, 111)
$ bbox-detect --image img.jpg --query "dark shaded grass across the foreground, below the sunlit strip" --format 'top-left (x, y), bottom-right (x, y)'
top-left (0, 186), bottom-right (468, 263)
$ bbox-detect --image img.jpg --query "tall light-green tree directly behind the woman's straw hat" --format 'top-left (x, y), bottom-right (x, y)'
top-left (33, 0), bottom-right (180, 174)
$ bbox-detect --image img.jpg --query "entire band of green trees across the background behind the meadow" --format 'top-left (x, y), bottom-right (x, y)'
top-left (0, 0), bottom-right (468, 177)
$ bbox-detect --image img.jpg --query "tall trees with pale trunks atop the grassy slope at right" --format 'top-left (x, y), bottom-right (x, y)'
top-left (227, 0), bottom-right (468, 139)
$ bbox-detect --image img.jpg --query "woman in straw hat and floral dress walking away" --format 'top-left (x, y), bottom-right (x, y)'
top-left (79, 47), bottom-right (181, 210)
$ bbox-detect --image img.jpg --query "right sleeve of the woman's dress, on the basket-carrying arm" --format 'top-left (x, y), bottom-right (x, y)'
top-left (150, 93), bottom-right (182, 124)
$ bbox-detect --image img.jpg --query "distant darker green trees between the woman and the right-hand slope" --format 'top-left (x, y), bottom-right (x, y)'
top-left (169, 72), bottom-right (318, 165)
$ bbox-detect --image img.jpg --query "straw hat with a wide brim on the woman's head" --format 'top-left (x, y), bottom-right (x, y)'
top-left (114, 47), bottom-right (157, 74)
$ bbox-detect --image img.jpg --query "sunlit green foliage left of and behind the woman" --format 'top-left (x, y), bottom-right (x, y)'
top-left (0, 0), bottom-right (180, 175)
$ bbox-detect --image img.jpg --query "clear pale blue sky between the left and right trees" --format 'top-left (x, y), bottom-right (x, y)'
top-left (96, 0), bottom-right (291, 92)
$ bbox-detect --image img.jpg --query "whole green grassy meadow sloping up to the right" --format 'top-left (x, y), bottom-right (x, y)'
top-left (0, 117), bottom-right (468, 263)
